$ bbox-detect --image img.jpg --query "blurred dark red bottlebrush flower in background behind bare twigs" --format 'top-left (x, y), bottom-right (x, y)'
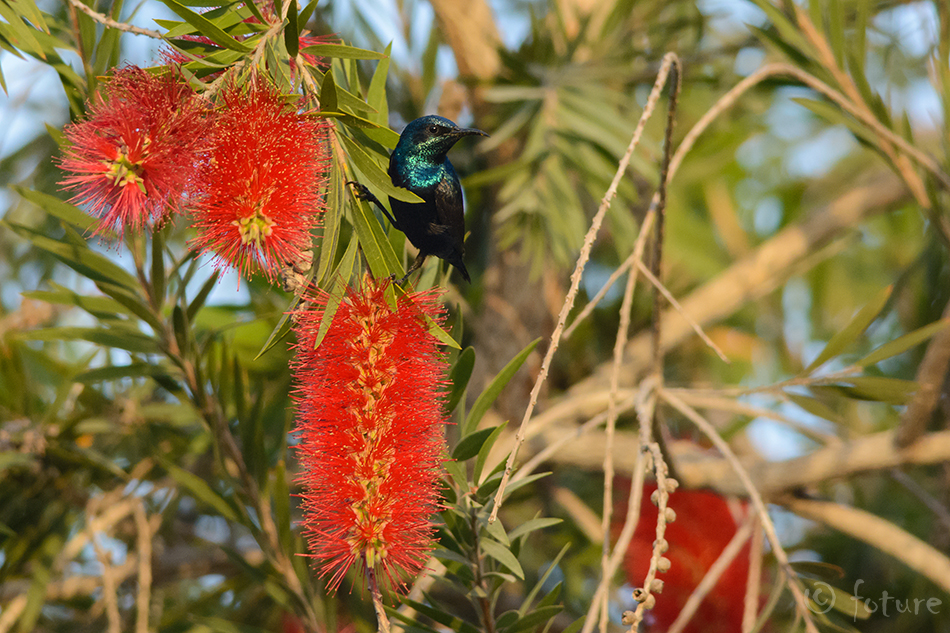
top-left (624, 484), bottom-right (749, 633)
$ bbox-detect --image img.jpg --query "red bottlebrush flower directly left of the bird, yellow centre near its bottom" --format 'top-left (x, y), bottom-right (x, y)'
top-left (193, 80), bottom-right (329, 280)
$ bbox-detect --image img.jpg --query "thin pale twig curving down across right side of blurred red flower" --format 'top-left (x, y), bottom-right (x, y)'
top-left (659, 390), bottom-right (818, 633)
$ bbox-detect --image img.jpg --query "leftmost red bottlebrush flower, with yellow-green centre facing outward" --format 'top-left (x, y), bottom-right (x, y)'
top-left (60, 66), bottom-right (207, 235)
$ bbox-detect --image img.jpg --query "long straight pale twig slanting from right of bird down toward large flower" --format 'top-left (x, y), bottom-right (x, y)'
top-left (488, 53), bottom-right (677, 522)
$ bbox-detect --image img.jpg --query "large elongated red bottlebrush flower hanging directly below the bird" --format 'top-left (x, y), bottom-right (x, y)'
top-left (293, 278), bottom-right (445, 590)
